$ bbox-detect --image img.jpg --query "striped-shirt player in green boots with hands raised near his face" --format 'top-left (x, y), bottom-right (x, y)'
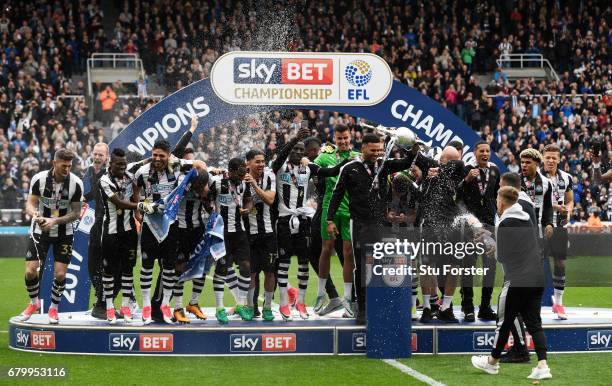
top-left (209, 158), bottom-right (253, 324)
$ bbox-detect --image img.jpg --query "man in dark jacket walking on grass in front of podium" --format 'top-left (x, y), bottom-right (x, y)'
top-left (472, 186), bottom-right (552, 379)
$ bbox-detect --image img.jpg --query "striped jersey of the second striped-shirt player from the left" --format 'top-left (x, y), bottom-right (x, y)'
top-left (98, 170), bottom-right (136, 235)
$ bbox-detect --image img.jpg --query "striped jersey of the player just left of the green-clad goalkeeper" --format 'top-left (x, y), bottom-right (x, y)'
top-left (276, 161), bottom-right (318, 217)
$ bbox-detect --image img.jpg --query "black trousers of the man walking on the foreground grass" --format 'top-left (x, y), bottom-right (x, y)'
top-left (491, 281), bottom-right (546, 361)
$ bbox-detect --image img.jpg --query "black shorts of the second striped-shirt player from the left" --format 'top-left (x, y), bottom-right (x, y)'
top-left (102, 230), bottom-right (138, 274)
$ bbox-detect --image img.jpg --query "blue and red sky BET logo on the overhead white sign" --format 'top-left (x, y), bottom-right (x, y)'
top-left (234, 57), bottom-right (334, 84)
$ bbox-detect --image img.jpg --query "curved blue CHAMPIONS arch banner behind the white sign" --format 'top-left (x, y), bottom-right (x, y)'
top-left (110, 79), bottom-right (506, 172)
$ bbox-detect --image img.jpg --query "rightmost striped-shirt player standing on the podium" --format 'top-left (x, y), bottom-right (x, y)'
top-left (544, 145), bottom-right (574, 320)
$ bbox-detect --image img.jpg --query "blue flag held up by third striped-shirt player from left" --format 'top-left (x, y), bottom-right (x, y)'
top-left (144, 169), bottom-right (198, 243)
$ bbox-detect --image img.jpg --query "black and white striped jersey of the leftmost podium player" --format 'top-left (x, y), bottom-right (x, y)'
top-left (30, 169), bottom-right (83, 237)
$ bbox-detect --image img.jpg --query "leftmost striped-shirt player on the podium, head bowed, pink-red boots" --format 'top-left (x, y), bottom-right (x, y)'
top-left (21, 149), bottom-right (83, 324)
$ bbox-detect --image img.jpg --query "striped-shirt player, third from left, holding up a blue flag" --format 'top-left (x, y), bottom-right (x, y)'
top-left (135, 140), bottom-right (206, 324)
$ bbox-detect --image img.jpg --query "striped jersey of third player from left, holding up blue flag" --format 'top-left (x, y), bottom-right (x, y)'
top-left (134, 158), bottom-right (193, 202)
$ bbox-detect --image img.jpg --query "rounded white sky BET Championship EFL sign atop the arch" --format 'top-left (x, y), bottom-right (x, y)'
top-left (210, 52), bottom-right (393, 106)
